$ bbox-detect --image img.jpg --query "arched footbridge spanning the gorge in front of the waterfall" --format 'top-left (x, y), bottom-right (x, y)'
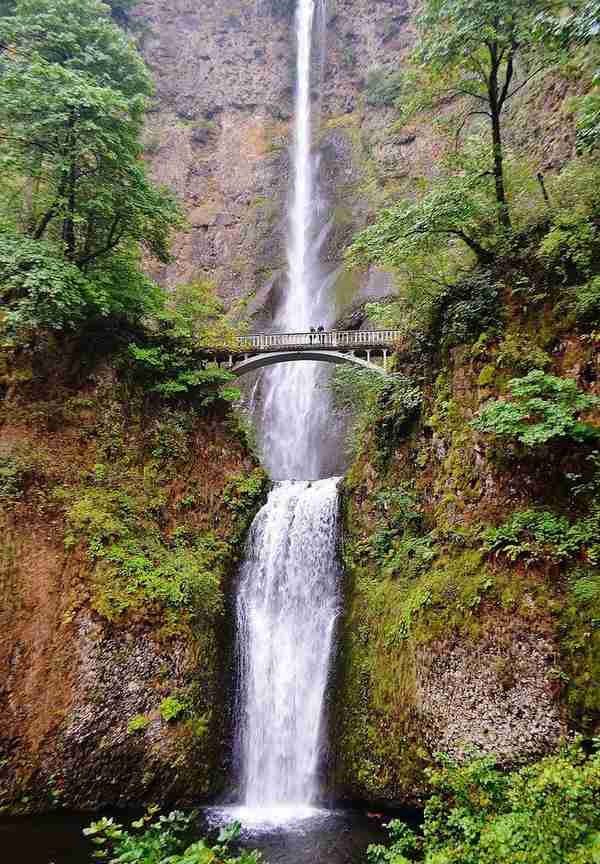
top-left (213, 330), bottom-right (401, 376)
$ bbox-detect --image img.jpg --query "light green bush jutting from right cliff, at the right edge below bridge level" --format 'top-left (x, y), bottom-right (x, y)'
top-left (471, 370), bottom-right (600, 449)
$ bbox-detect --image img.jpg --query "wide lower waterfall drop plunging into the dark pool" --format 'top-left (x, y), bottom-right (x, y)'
top-left (237, 477), bottom-right (340, 809)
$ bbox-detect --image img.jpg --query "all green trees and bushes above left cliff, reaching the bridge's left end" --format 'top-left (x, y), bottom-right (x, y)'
top-left (0, 0), bottom-right (245, 406)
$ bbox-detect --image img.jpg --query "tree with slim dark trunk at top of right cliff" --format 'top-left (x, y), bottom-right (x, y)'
top-left (416, 0), bottom-right (563, 229)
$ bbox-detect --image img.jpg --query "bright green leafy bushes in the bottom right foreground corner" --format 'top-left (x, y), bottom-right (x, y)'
top-left (367, 744), bottom-right (600, 864)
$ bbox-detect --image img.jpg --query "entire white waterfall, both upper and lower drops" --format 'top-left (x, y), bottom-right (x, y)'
top-left (237, 0), bottom-right (339, 821)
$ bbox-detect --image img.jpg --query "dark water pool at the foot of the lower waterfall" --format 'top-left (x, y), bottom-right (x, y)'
top-left (0, 810), bottom-right (398, 864)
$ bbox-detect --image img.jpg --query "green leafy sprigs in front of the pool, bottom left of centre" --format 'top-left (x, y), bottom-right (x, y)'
top-left (83, 807), bottom-right (260, 864)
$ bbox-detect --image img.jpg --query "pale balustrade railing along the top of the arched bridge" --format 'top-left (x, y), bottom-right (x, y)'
top-left (239, 330), bottom-right (401, 351)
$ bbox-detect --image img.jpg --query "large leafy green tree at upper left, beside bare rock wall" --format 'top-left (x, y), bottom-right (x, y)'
top-left (0, 0), bottom-right (181, 271)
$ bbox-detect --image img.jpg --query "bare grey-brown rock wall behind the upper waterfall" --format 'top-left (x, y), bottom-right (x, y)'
top-left (137, 0), bottom-right (573, 326)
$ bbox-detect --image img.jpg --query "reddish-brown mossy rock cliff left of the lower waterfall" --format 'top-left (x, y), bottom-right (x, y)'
top-left (0, 346), bottom-right (266, 812)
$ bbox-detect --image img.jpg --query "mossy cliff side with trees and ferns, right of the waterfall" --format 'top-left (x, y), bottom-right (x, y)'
top-left (334, 0), bottom-right (600, 804)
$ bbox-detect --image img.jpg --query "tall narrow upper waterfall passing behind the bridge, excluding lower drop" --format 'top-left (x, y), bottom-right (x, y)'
top-left (261, 0), bottom-right (331, 480)
